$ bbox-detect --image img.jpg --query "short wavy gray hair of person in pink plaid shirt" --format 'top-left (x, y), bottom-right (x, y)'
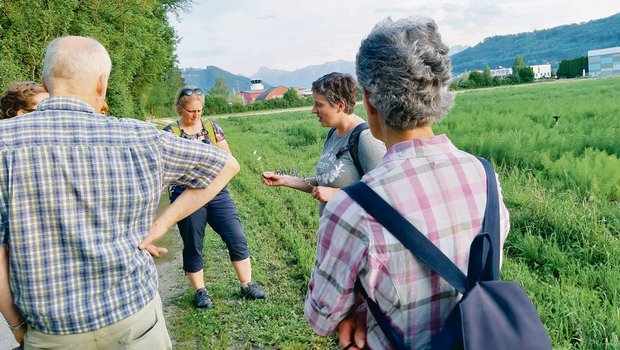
top-left (355, 17), bottom-right (454, 130)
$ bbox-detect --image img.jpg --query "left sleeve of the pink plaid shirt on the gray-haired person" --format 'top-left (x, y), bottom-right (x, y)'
top-left (304, 191), bottom-right (367, 336)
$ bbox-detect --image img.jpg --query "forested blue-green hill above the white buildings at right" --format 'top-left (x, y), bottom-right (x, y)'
top-left (452, 13), bottom-right (620, 74)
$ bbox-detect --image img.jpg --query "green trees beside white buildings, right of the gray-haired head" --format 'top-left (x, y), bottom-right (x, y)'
top-left (451, 55), bottom-right (534, 90)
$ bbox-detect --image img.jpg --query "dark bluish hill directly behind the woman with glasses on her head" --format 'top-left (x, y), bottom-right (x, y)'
top-left (181, 66), bottom-right (271, 92)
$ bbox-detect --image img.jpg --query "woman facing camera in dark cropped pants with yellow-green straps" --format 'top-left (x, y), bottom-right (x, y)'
top-left (164, 85), bottom-right (267, 308)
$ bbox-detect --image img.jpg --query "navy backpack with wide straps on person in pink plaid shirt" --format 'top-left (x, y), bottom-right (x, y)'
top-left (344, 157), bottom-right (552, 350)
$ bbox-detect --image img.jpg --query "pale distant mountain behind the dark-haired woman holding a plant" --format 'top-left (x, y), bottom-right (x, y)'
top-left (252, 60), bottom-right (355, 88)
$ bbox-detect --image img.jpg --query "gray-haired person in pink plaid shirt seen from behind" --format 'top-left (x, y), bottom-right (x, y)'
top-left (304, 18), bottom-right (509, 349)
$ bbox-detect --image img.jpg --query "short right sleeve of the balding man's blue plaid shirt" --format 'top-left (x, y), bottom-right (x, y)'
top-left (159, 131), bottom-right (228, 188)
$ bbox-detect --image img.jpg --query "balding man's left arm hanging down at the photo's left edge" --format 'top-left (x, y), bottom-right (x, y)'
top-left (0, 245), bottom-right (27, 343)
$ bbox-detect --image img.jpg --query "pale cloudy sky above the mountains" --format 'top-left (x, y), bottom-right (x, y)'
top-left (170, 0), bottom-right (620, 76)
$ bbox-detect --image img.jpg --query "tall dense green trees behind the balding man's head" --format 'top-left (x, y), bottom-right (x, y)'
top-left (0, 0), bottom-right (191, 119)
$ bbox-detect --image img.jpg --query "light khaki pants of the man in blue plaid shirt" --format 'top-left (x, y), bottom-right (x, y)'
top-left (24, 294), bottom-right (172, 350)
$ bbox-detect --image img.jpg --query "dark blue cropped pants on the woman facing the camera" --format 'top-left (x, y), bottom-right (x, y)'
top-left (170, 188), bottom-right (250, 272)
